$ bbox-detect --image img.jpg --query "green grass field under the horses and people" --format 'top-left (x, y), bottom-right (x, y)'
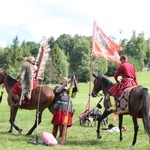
top-left (0, 72), bottom-right (150, 150)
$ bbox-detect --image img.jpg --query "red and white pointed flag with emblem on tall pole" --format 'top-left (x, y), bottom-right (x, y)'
top-left (92, 21), bottom-right (122, 64)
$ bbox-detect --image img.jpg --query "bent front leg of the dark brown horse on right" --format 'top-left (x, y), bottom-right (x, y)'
top-left (96, 109), bottom-right (112, 139)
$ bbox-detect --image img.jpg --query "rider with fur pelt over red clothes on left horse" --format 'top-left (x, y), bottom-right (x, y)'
top-left (12, 56), bottom-right (37, 106)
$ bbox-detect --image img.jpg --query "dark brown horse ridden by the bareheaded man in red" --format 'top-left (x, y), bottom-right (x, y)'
top-left (91, 74), bottom-right (150, 146)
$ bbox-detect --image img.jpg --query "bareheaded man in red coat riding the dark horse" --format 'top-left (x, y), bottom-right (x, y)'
top-left (108, 55), bottom-right (137, 111)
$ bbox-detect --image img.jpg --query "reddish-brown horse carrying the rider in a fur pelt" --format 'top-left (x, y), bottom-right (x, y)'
top-left (0, 70), bottom-right (55, 135)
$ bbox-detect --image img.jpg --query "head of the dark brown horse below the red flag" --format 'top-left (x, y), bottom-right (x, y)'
top-left (91, 74), bottom-right (102, 97)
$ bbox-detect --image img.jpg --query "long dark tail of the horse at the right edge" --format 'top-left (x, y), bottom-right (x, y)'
top-left (142, 88), bottom-right (150, 138)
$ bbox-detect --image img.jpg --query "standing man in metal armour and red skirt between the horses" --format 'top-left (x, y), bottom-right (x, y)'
top-left (51, 76), bottom-right (77, 138)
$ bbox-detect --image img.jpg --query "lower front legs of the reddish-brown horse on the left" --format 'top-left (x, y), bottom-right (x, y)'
top-left (8, 106), bottom-right (23, 134)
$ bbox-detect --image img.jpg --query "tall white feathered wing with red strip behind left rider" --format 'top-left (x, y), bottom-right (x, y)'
top-left (35, 36), bottom-right (50, 80)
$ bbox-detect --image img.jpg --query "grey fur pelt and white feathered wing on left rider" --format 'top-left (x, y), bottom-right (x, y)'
top-left (20, 37), bottom-right (50, 104)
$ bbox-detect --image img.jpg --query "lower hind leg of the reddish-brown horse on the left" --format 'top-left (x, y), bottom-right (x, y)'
top-left (26, 110), bottom-right (43, 135)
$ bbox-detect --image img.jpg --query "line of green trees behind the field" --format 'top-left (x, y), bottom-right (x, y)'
top-left (0, 31), bottom-right (150, 84)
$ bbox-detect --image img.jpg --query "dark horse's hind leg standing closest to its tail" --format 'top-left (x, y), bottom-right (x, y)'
top-left (132, 116), bottom-right (139, 146)
